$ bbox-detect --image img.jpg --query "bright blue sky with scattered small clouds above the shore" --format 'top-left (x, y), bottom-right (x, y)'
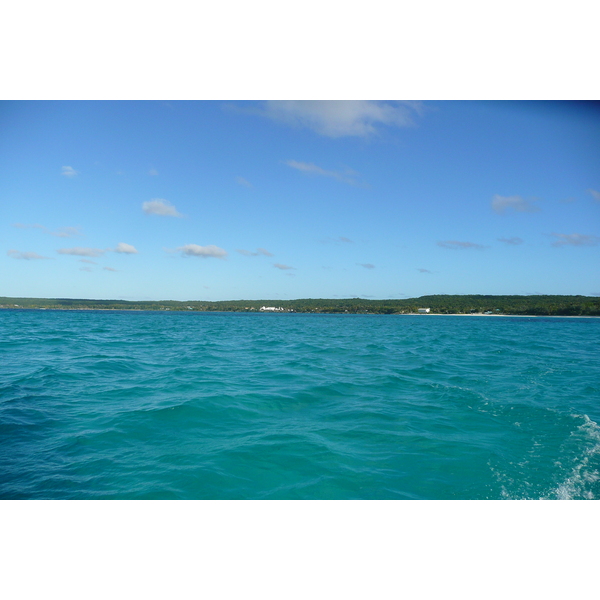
top-left (0, 101), bottom-right (600, 300)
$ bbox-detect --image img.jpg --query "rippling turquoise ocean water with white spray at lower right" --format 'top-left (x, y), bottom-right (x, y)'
top-left (0, 310), bottom-right (600, 500)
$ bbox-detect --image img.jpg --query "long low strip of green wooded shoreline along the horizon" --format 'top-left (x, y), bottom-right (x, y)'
top-left (0, 295), bottom-right (600, 316)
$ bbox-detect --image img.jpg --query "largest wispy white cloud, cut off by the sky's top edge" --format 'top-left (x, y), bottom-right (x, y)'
top-left (255, 100), bottom-right (422, 138)
